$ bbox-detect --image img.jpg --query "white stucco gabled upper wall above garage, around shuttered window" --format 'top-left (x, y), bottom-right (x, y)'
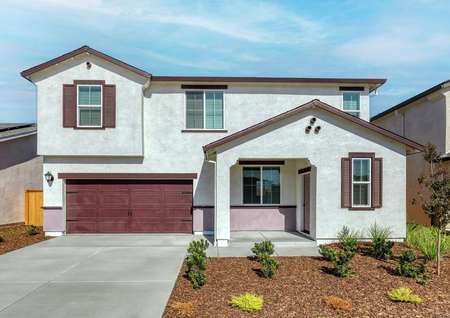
top-left (33, 55), bottom-right (144, 156)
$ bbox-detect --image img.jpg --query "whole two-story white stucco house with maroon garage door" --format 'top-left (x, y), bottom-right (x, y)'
top-left (22, 46), bottom-right (422, 246)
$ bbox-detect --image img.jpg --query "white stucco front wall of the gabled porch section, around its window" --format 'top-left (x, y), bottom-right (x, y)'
top-left (216, 110), bottom-right (406, 240)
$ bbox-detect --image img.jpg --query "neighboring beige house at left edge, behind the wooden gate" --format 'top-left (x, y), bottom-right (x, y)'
top-left (0, 124), bottom-right (42, 225)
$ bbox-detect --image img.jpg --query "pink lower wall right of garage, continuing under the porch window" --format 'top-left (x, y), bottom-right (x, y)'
top-left (193, 206), bottom-right (296, 232)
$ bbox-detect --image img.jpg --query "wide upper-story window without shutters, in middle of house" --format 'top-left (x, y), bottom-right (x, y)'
top-left (186, 91), bottom-right (223, 129)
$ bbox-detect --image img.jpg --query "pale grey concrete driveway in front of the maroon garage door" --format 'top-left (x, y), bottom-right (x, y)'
top-left (0, 235), bottom-right (193, 318)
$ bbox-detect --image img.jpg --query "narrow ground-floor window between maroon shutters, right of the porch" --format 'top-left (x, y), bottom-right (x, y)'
top-left (352, 158), bottom-right (372, 207)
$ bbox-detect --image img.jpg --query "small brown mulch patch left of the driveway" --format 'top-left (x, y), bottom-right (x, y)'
top-left (0, 225), bottom-right (50, 255)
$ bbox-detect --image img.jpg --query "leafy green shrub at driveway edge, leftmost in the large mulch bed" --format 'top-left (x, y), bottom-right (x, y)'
top-left (186, 239), bottom-right (209, 289)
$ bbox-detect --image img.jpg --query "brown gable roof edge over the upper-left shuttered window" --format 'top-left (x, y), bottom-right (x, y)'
top-left (20, 45), bottom-right (152, 80)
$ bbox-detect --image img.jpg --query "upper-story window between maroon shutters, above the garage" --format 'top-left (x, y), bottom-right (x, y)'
top-left (77, 85), bottom-right (103, 127)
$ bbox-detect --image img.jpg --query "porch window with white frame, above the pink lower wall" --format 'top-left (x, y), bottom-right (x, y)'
top-left (243, 167), bottom-right (281, 204)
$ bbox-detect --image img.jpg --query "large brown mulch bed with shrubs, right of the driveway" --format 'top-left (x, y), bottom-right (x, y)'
top-left (164, 244), bottom-right (450, 318)
